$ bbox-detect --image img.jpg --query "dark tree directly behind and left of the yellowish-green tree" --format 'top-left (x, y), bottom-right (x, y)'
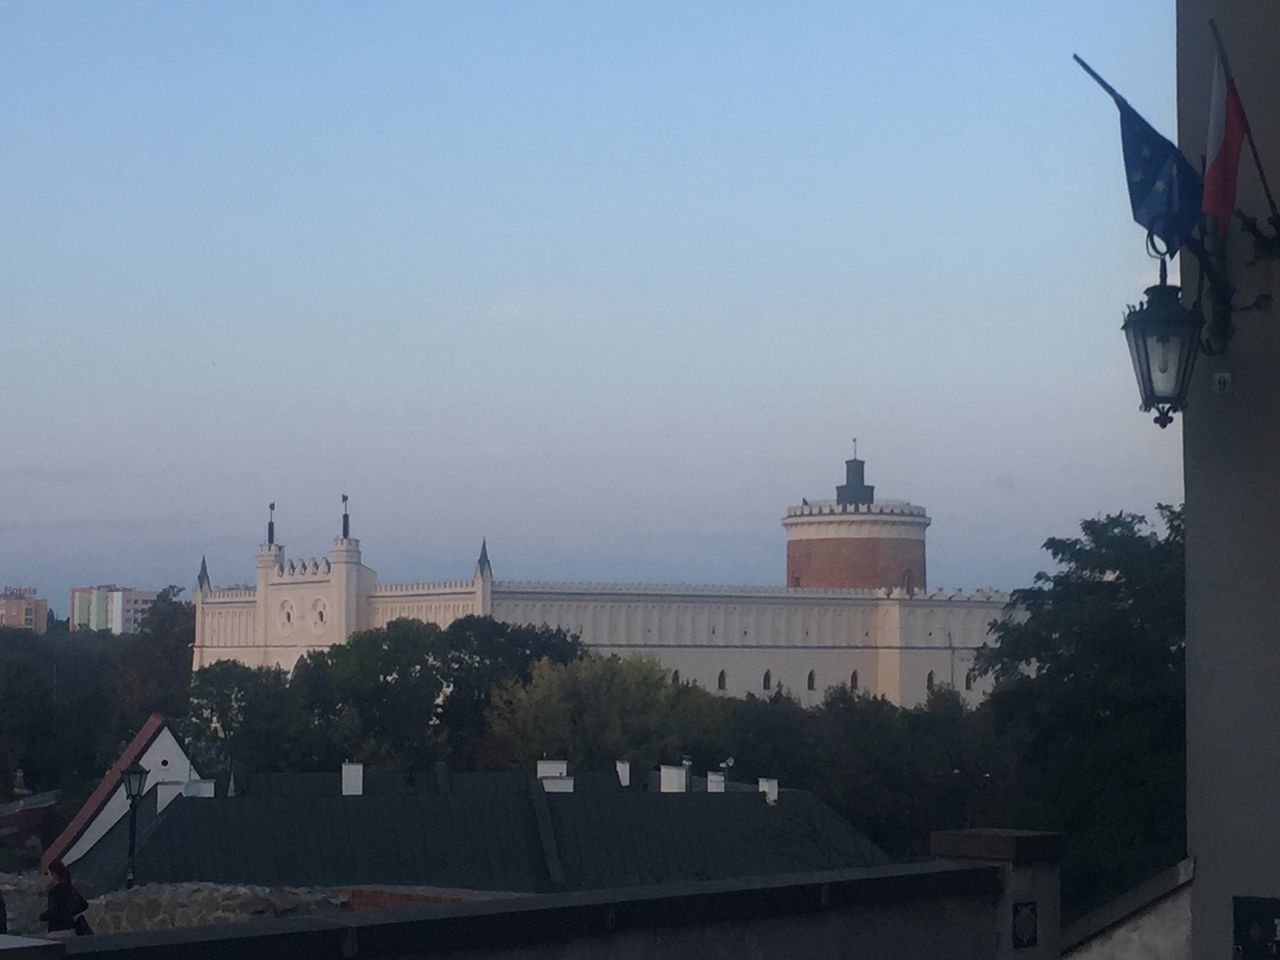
top-left (439, 616), bottom-right (584, 769)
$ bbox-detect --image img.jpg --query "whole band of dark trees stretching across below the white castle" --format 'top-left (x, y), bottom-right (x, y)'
top-left (0, 507), bottom-right (1185, 914)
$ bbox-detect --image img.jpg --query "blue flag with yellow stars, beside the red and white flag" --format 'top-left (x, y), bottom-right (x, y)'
top-left (1116, 97), bottom-right (1204, 256)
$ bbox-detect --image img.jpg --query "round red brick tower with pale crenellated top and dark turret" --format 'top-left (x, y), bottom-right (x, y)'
top-left (782, 457), bottom-right (929, 593)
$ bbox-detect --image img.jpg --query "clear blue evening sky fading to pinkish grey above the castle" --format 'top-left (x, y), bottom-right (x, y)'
top-left (0, 0), bottom-right (1183, 613)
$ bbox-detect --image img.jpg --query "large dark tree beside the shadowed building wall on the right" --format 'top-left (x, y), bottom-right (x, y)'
top-left (977, 504), bottom-right (1185, 910)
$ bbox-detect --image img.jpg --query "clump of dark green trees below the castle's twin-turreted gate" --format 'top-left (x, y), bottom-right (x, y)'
top-left (180, 617), bottom-right (581, 774)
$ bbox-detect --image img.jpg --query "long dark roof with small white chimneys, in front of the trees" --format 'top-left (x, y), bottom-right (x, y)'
top-left (129, 773), bottom-right (888, 892)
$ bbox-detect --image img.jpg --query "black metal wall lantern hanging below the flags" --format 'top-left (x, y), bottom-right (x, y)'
top-left (1123, 260), bottom-right (1204, 428)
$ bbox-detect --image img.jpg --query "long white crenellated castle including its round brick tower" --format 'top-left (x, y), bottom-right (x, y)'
top-left (193, 458), bottom-right (1007, 705)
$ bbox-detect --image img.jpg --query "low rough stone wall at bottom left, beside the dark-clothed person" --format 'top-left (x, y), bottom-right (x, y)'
top-left (0, 873), bottom-right (351, 934)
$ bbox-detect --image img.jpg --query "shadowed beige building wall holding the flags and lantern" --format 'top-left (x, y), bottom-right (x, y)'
top-left (1172, 0), bottom-right (1280, 960)
